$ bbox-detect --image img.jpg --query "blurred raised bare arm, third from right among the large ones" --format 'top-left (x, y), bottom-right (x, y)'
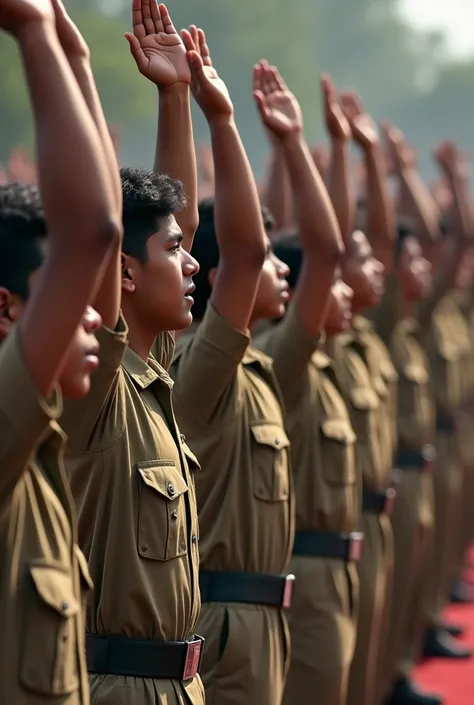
top-left (341, 92), bottom-right (395, 274)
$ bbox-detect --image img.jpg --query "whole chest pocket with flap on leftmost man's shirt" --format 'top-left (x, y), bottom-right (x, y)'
top-left (20, 563), bottom-right (83, 696)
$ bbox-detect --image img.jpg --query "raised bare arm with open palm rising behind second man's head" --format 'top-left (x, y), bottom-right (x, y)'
top-left (125, 0), bottom-right (199, 252)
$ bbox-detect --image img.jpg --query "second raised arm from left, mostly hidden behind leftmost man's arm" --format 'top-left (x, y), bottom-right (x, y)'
top-left (53, 0), bottom-right (122, 329)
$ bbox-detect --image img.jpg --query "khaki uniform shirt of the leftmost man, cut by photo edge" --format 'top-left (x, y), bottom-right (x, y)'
top-left (0, 328), bottom-right (92, 705)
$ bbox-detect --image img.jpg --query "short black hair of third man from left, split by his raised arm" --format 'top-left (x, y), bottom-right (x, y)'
top-left (191, 198), bottom-right (274, 320)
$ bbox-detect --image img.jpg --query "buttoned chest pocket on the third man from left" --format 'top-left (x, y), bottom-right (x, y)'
top-left (250, 423), bottom-right (290, 502)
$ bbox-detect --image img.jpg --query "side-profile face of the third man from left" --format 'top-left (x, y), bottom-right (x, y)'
top-left (252, 238), bottom-right (290, 322)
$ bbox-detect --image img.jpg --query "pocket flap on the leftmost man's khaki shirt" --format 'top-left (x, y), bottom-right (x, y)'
top-left (30, 564), bottom-right (79, 617)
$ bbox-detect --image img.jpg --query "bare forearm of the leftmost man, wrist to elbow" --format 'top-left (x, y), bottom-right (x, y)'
top-left (20, 23), bottom-right (118, 238)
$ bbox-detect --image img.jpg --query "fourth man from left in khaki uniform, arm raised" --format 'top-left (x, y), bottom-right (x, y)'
top-left (257, 67), bottom-right (361, 705)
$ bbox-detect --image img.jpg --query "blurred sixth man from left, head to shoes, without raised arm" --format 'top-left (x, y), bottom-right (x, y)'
top-left (375, 225), bottom-right (441, 705)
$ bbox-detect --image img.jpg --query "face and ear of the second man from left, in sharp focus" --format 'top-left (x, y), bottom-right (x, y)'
top-left (122, 216), bottom-right (199, 334)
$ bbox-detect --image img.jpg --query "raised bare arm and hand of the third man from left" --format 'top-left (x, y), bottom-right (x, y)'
top-left (183, 27), bottom-right (266, 332)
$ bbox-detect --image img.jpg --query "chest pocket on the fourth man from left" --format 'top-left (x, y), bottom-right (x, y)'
top-left (321, 419), bottom-right (356, 487)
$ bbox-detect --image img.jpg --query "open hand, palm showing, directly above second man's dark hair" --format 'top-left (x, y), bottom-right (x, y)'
top-left (125, 0), bottom-right (191, 88)
